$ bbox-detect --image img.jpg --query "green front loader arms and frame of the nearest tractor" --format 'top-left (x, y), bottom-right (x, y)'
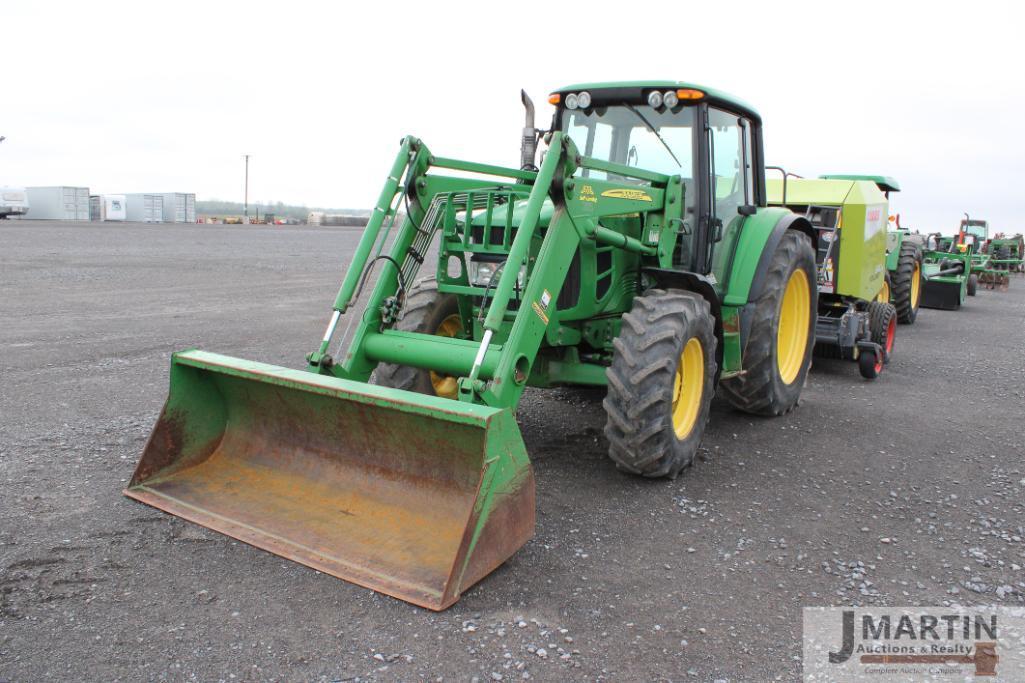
top-left (308, 132), bottom-right (683, 408)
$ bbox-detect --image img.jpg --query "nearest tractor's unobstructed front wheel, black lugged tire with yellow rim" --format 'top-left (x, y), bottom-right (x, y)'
top-left (604, 289), bottom-right (716, 478)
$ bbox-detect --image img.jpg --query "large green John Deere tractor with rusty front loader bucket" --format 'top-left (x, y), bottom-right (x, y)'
top-left (126, 82), bottom-right (818, 609)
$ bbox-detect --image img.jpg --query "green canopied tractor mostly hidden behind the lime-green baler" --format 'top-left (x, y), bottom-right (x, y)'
top-left (819, 173), bottom-right (921, 325)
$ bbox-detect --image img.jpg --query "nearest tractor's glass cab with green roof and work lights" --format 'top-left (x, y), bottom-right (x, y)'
top-left (548, 81), bottom-right (765, 287)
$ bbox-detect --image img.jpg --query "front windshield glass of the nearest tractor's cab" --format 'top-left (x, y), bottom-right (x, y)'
top-left (562, 105), bottom-right (695, 180)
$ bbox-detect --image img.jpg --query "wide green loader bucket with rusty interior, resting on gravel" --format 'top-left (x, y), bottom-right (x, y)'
top-left (125, 351), bottom-right (534, 610)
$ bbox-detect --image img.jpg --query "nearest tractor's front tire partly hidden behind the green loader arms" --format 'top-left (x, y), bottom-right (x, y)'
top-left (370, 277), bottom-right (465, 398)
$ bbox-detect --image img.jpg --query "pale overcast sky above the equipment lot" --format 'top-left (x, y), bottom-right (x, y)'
top-left (0, 0), bottom-right (1025, 233)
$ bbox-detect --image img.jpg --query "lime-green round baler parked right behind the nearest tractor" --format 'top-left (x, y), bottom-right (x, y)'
top-left (768, 174), bottom-right (897, 379)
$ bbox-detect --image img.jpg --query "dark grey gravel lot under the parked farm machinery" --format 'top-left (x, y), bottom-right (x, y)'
top-left (0, 222), bottom-right (1025, 682)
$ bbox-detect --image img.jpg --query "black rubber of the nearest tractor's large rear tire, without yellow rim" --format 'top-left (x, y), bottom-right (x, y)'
top-left (720, 230), bottom-right (818, 415)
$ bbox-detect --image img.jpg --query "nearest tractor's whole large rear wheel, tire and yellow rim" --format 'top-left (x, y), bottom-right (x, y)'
top-left (720, 230), bottom-right (818, 415)
